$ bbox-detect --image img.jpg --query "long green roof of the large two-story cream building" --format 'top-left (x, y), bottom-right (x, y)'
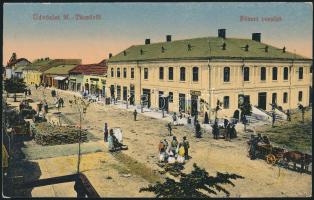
top-left (108, 37), bottom-right (310, 62)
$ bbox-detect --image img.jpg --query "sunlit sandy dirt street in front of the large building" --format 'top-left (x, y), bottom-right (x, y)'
top-left (16, 86), bottom-right (312, 197)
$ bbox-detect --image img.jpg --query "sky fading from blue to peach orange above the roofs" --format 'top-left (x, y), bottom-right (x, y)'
top-left (3, 2), bottom-right (313, 64)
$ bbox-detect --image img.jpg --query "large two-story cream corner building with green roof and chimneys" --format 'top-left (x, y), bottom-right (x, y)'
top-left (107, 29), bottom-right (312, 118)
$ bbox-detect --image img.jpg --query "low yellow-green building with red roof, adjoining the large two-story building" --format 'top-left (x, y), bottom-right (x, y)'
top-left (69, 60), bottom-right (107, 97)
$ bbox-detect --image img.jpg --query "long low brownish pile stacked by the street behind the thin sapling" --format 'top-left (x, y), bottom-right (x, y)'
top-left (32, 122), bottom-right (87, 146)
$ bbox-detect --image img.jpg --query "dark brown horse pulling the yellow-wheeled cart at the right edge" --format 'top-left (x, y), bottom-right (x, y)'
top-left (283, 151), bottom-right (312, 172)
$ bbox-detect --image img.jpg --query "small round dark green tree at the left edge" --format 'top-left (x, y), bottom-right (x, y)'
top-left (4, 78), bottom-right (27, 102)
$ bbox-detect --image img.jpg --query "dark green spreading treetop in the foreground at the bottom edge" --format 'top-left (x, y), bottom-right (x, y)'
top-left (140, 163), bottom-right (244, 198)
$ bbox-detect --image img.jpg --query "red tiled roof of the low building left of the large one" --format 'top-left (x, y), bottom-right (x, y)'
top-left (69, 64), bottom-right (108, 75)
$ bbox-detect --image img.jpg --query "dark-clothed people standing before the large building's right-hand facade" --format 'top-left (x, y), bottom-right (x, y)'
top-left (212, 119), bottom-right (237, 141)
